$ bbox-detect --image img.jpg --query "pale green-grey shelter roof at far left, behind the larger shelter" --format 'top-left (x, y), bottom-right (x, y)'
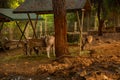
top-left (0, 8), bottom-right (43, 20)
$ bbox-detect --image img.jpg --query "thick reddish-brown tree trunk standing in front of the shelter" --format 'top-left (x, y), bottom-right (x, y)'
top-left (52, 0), bottom-right (69, 57)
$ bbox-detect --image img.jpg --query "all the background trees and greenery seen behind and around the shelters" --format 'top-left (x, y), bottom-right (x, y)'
top-left (0, 0), bottom-right (120, 39)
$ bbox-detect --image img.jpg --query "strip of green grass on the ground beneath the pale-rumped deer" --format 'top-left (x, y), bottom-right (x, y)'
top-left (0, 54), bottom-right (55, 62)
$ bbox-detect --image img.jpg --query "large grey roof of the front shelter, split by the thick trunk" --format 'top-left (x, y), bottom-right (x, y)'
top-left (13, 0), bottom-right (91, 13)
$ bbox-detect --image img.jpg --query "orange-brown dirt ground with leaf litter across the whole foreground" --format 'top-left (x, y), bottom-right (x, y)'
top-left (0, 34), bottom-right (120, 80)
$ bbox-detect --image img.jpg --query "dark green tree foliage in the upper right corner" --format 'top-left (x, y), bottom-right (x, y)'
top-left (91, 0), bottom-right (120, 25)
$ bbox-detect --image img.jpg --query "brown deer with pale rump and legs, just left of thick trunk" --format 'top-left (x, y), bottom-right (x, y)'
top-left (24, 36), bottom-right (55, 58)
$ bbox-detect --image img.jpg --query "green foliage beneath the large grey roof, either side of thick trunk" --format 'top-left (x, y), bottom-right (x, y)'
top-left (41, 13), bottom-right (77, 34)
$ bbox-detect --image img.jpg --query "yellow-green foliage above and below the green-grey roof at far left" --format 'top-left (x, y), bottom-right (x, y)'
top-left (2, 0), bottom-right (25, 39)
